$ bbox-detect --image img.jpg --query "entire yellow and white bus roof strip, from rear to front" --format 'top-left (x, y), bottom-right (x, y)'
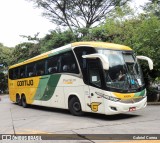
top-left (9, 41), bottom-right (132, 68)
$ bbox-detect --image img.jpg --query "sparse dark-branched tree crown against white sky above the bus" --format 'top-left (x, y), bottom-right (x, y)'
top-left (28, 0), bottom-right (130, 31)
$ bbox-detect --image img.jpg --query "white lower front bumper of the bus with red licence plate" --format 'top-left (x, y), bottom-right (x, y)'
top-left (105, 97), bottom-right (147, 115)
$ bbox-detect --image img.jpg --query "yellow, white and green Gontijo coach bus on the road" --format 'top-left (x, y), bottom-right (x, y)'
top-left (8, 41), bottom-right (153, 116)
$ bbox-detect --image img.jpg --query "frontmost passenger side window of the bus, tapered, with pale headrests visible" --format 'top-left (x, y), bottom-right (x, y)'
top-left (60, 51), bottom-right (79, 74)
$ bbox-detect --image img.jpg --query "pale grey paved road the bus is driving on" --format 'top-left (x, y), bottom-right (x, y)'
top-left (0, 95), bottom-right (160, 142)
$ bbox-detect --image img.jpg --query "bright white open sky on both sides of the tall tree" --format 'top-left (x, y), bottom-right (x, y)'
top-left (0, 0), bottom-right (148, 47)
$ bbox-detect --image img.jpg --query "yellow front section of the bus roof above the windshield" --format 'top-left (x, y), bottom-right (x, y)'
top-left (71, 41), bottom-right (132, 51)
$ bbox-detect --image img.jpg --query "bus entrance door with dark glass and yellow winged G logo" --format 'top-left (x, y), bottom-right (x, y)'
top-left (87, 59), bottom-right (104, 113)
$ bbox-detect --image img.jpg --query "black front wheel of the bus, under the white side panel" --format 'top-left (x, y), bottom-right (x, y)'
top-left (68, 97), bottom-right (83, 116)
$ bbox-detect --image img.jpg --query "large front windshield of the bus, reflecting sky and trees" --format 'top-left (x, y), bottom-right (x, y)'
top-left (98, 49), bottom-right (144, 91)
